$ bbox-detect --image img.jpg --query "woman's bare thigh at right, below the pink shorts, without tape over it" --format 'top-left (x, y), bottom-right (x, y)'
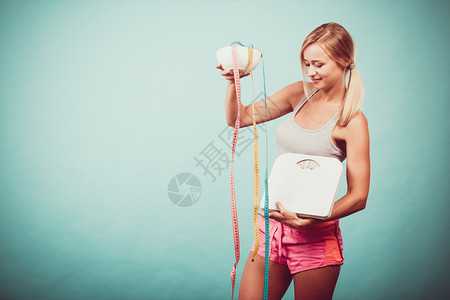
top-left (294, 266), bottom-right (341, 300)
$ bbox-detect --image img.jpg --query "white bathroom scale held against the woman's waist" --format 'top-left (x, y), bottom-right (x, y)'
top-left (260, 153), bottom-right (344, 219)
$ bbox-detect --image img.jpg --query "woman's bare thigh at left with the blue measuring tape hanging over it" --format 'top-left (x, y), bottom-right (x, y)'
top-left (239, 252), bottom-right (292, 300)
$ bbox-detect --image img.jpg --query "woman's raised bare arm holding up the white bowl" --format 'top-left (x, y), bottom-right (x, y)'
top-left (216, 64), bottom-right (304, 127)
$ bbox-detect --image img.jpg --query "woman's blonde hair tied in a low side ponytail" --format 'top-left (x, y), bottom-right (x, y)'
top-left (300, 23), bottom-right (364, 126)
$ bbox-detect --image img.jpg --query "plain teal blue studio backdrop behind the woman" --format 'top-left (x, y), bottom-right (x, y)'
top-left (0, 0), bottom-right (450, 299)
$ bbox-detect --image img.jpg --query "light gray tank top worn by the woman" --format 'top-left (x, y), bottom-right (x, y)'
top-left (275, 89), bottom-right (347, 162)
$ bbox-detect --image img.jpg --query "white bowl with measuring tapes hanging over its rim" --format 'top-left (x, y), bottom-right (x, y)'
top-left (216, 46), bottom-right (262, 73)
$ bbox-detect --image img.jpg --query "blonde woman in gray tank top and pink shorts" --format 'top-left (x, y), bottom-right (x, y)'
top-left (216, 23), bottom-right (370, 300)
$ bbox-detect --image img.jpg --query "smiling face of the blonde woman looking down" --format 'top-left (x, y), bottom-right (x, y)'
top-left (303, 43), bottom-right (345, 90)
